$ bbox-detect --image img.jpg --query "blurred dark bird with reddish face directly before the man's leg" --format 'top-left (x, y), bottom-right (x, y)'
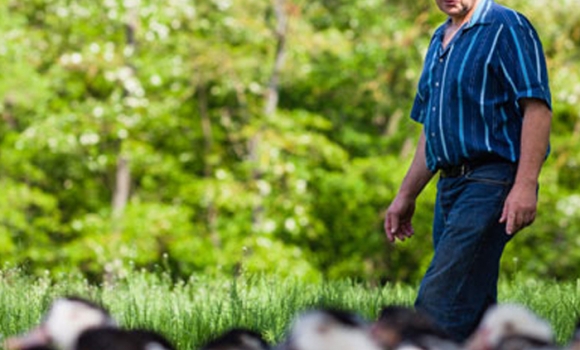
top-left (371, 305), bottom-right (459, 350)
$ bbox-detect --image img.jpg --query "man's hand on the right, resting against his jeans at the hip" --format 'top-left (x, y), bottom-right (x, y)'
top-left (499, 183), bottom-right (538, 235)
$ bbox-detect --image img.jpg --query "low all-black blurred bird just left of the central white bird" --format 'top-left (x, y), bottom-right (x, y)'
top-left (201, 328), bottom-right (270, 350)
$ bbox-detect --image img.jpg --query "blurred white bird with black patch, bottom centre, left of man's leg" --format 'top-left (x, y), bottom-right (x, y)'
top-left (280, 309), bottom-right (380, 350)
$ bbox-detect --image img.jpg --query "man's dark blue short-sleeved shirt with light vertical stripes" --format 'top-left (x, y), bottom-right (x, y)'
top-left (411, 0), bottom-right (551, 171)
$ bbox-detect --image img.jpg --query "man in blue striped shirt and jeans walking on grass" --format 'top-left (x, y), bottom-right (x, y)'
top-left (385, 0), bottom-right (551, 341)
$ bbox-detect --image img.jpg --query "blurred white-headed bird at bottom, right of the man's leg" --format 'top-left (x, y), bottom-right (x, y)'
top-left (465, 304), bottom-right (557, 350)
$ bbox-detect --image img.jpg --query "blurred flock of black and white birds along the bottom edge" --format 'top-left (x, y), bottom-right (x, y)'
top-left (4, 297), bottom-right (580, 350)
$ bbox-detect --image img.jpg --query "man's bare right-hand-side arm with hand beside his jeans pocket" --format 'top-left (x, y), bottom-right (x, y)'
top-left (500, 99), bottom-right (552, 235)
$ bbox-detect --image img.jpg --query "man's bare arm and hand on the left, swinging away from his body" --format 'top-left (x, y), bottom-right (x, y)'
top-left (385, 132), bottom-right (433, 242)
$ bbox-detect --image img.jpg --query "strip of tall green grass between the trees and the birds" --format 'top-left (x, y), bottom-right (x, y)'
top-left (0, 269), bottom-right (580, 350)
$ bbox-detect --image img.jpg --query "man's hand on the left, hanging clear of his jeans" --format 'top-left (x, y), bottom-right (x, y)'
top-left (385, 196), bottom-right (415, 242)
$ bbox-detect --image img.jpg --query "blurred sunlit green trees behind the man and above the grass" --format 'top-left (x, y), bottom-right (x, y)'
top-left (0, 0), bottom-right (580, 283)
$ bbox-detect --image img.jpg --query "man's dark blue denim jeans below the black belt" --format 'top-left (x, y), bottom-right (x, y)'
top-left (415, 163), bottom-right (516, 341)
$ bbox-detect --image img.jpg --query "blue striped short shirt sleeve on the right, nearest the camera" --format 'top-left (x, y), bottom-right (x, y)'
top-left (498, 14), bottom-right (552, 109)
